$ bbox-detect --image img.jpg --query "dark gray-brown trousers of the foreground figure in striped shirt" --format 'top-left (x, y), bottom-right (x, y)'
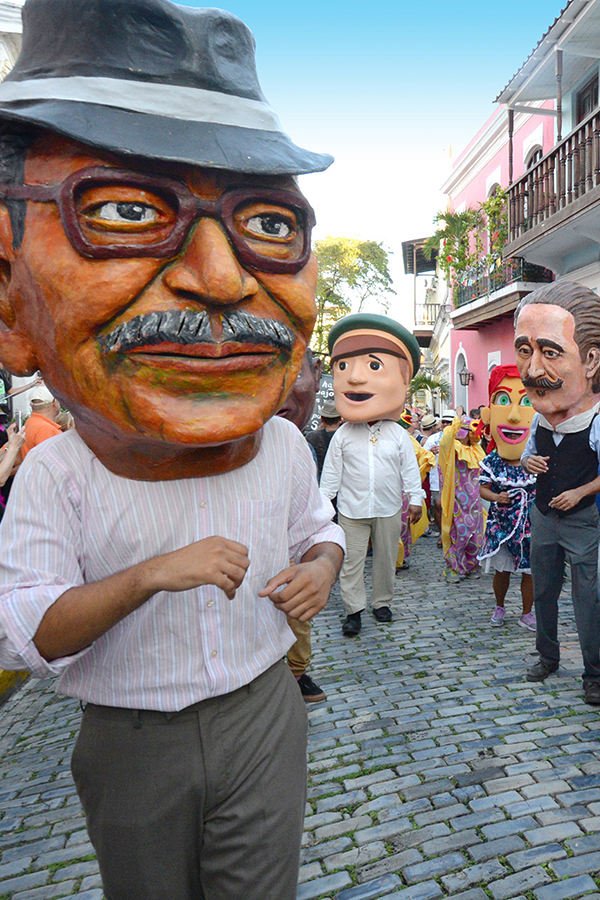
top-left (72, 661), bottom-right (307, 900)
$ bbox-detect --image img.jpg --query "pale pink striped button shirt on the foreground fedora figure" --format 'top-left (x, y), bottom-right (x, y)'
top-left (0, 418), bottom-right (343, 711)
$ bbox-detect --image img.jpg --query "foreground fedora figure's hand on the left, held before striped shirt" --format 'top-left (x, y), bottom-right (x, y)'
top-left (145, 536), bottom-right (250, 600)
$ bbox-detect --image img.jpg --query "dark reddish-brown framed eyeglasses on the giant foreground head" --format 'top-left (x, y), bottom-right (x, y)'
top-left (0, 166), bottom-right (315, 275)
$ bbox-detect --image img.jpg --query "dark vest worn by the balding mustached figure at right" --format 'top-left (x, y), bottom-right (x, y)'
top-left (535, 416), bottom-right (598, 517)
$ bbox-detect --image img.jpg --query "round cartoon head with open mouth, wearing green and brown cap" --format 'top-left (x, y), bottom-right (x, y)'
top-left (329, 313), bottom-right (421, 422)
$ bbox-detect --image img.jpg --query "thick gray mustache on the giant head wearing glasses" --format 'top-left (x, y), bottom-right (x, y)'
top-left (98, 309), bottom-right (294, 353)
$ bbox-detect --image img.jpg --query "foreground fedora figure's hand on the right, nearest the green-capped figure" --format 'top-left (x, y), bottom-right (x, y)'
top-left (258, 557), bottom-right (337, 622)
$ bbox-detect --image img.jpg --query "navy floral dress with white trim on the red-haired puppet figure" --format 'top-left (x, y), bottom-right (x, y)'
top-left (478, 450), bottom-right (536, 574)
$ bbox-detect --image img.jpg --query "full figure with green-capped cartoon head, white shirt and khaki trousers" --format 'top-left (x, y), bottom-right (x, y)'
top-left (320, 313), bottom-right (424, 636)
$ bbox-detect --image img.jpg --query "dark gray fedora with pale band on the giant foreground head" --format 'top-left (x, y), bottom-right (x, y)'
top-left (0, 0), bottom-right (333, 174)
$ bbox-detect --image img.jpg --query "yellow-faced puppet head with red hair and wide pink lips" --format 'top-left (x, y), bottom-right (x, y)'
top-left (481, 366), bottom-right (535, 461)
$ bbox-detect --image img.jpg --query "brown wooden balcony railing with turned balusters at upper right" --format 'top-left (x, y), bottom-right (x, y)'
top-left (508, 109), bottom-right (600, 242)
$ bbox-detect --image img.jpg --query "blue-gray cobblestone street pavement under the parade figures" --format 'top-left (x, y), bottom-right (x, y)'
top-left (0, 538), bottom-right (600, 900)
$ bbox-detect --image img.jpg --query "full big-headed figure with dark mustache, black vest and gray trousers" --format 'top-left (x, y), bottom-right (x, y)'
top-left (515, 282), bottom-right (600, 705)
